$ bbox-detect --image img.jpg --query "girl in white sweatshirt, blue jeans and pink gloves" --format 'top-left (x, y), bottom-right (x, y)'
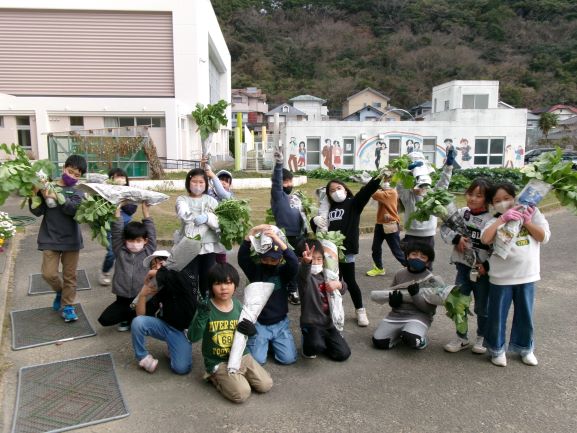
top-left (481, 182), bottom-right (551, 367)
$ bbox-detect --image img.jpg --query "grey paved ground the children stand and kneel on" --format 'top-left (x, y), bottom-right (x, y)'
top-left (0, 197), bottom-right (577, 433)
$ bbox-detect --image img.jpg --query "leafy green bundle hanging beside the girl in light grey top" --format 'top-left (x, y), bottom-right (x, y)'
top-left (214, 199), bottom-right (252, 250)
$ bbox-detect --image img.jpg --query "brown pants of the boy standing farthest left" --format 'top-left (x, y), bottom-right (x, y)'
top-left (42, 250), bottom-right (80, 307)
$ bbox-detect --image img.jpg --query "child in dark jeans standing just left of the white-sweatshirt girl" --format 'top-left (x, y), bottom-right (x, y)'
top-left (441, 178), bottom-right (492, 353)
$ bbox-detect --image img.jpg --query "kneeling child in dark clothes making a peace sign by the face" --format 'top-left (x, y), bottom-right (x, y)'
top-left (298, 240), bottom-right (351, 361)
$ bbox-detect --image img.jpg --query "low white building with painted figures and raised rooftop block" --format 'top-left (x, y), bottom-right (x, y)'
top-left (283, 81), bottom-right (527, 170)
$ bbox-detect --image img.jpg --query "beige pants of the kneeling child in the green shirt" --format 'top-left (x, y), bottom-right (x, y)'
top-left (209, 354), bottom-right (272, 403)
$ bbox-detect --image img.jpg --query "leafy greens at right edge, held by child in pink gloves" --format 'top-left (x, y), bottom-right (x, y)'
top-left (521, 147), bottom-right (577, 213)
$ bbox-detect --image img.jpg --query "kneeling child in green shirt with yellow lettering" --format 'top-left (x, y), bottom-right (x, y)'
top-left (188, 263), bottom-right (272, 403)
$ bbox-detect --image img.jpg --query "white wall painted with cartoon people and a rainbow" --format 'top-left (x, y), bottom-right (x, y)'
top-left (286, 120), bottom-right (526, 171)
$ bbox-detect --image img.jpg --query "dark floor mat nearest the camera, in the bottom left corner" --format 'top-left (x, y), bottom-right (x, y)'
top-left (12, 353), bottom-right (129, 433)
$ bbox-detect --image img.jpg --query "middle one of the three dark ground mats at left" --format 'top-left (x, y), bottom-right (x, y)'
top-left (10, 304), bottom-right (96, 350)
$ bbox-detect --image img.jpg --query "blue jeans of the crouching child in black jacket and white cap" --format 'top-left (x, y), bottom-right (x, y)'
top-left (130, 316), bottom-right (192, 374)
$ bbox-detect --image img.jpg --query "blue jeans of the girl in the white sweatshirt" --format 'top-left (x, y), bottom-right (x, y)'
top-left (484, 283), bottom-right (535, 356)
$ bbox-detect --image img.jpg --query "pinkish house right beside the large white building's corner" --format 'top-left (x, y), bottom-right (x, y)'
top-left (232, 87), bottom-right (268, 135)
